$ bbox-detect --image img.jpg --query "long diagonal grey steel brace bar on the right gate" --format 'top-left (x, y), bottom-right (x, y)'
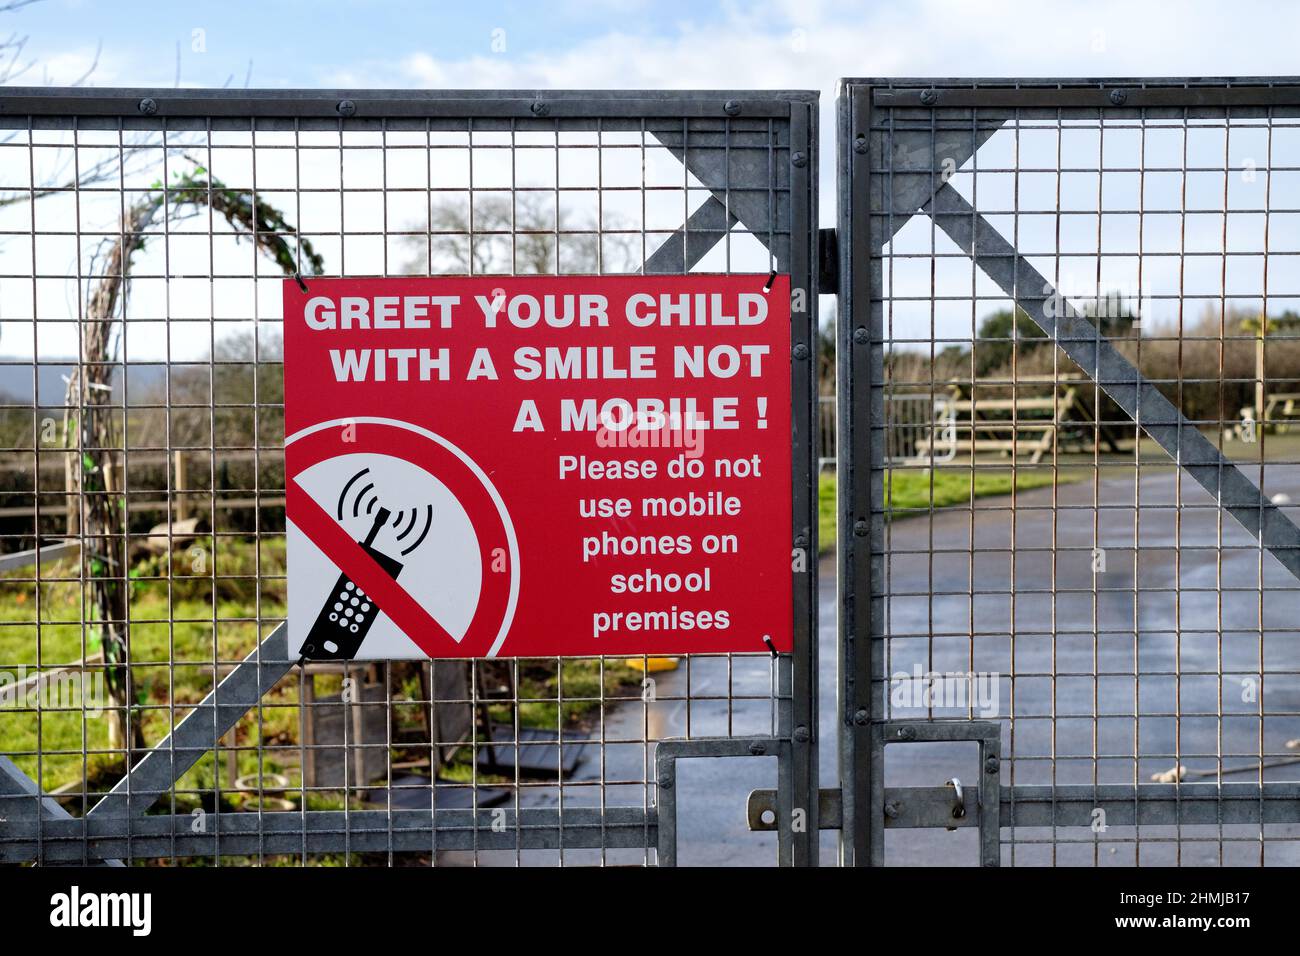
top-left (926, 185), bottom-right (1300, 578)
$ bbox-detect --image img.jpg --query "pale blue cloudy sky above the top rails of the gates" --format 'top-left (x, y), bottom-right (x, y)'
top-left (0, 0), bottom-right (1300, 361)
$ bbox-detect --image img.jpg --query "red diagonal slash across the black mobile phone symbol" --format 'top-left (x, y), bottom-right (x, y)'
top-left (285, 479), bottom-right (458, 657)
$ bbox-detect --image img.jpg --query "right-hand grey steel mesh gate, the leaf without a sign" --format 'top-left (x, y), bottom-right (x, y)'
top-left (840, 81), bottom-right (1300, 865)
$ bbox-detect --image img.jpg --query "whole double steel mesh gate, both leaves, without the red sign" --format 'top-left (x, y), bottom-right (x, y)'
top-left (15, 81), bottom-right (1300, 865)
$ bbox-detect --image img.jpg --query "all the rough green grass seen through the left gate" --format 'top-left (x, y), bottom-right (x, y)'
top-left (0, 536), bottom-right (642, 812)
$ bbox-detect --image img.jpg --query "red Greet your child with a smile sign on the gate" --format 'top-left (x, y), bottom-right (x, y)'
top-left (285, 274), bottom-right (801, 659)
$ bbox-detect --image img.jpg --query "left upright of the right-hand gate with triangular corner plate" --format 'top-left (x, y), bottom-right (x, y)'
top-left (836, 81), bottom-right (996, 866)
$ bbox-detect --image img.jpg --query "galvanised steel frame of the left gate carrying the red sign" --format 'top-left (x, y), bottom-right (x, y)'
top-left (0, 88), bottom-right (819, 864)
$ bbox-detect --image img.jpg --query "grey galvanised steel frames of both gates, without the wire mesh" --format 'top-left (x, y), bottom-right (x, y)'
top-left (12, 72), bottom-right (1300, 865)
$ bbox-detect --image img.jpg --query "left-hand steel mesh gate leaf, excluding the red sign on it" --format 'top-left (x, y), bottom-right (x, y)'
top-left (0, 88), bottom-right (818, 864)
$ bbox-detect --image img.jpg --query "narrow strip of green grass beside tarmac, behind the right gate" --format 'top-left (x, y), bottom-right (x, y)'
top-left (818, 466), bottom-right (1082, 554)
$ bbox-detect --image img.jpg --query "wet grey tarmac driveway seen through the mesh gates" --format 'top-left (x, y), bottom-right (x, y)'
top-left (443, 466), bottom-right (1300, 865)
